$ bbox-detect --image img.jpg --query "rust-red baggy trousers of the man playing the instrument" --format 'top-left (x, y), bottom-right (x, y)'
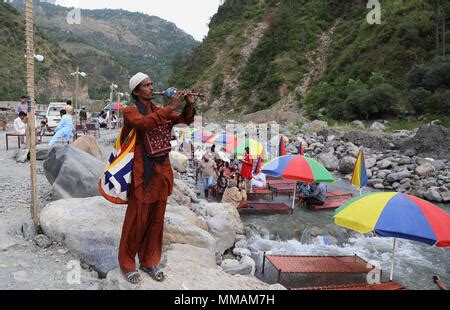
top-left (119, 195), bottom-right (167, 273)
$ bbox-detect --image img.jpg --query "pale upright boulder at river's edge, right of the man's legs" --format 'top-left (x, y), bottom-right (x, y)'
top-left (207, 217), bottom-right (236, 255)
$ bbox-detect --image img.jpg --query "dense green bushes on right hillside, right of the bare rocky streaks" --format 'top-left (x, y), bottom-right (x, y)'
top-left (306, 0), bottom-right (450, 120)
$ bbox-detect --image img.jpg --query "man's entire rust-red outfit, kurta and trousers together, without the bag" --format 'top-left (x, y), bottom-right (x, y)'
top-left (119, 100), bottom-right (195, 272)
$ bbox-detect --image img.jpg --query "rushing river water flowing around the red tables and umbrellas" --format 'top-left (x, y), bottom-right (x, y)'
top-left (241, 180), bottom-right (450, 289)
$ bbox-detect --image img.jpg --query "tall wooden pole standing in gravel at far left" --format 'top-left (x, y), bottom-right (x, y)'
top-left (25, 0), bottom-right (39, 230)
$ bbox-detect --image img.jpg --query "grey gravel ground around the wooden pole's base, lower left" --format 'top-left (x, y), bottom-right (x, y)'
top-left (0, 132), bottom-right (108, 290)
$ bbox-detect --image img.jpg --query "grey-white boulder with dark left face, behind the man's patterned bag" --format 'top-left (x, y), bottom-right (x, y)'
top-left (44, 145), bottom-right (106, 198)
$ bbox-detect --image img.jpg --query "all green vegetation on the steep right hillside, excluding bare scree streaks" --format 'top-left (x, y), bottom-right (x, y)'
top-left (171, 0), bottom-right (450, 121)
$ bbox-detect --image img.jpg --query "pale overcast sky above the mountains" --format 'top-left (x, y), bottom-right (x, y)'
top-left (56, 0), bottom-right (221, 41)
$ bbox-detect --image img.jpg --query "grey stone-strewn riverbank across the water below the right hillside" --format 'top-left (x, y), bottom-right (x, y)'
top-left (274, 121), bottom-right (450, 203)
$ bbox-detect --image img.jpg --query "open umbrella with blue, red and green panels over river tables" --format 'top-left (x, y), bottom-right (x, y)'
top-left (261, 155), bottom-right (336, 209)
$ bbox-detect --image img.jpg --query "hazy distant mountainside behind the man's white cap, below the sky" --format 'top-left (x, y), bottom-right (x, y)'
top-left (6, 0), bottom-right (198, 99)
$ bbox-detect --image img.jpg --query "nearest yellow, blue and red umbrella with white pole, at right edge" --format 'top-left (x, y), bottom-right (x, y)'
top-left (334, 192), bottom-right (450, 281)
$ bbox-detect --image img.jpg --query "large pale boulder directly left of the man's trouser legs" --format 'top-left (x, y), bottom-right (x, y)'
top-left (40, 197), bottom-right (126, 276)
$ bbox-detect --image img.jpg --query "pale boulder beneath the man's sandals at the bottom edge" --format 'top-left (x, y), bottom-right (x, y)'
top-left (105, 244), bottom-right (284, 290)
